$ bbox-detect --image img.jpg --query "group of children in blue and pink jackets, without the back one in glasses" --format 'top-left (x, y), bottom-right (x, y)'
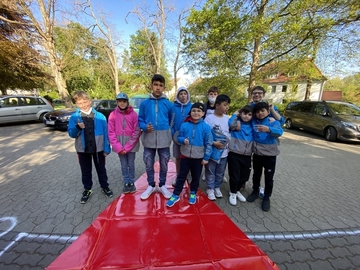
top-left (68, 74), bottom-right (283, 211)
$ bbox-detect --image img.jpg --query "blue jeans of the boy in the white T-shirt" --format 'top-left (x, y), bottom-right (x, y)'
top-left (205, 157), bottom-right (227, 189)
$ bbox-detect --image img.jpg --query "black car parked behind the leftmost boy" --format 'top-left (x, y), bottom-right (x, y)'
top-left (44, 99), bottom-right (116, 130)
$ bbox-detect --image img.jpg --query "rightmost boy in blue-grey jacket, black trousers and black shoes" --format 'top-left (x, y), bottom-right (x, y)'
top-left (246, 102), bottom-right (283, 211)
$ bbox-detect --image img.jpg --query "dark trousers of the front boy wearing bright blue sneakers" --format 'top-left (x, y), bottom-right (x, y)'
top-left (174, 158), bottom-right (202, 196)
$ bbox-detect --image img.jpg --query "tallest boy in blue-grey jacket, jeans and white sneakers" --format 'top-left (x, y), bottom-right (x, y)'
top-left (139, 74), bottom-right (175, 200)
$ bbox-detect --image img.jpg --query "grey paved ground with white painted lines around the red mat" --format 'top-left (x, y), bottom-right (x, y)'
top-left (0, 123), bottom-right (360, 270)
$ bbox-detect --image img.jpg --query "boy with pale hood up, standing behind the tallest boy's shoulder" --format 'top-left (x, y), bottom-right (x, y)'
top-left (171, 86), bottom-right (192, 176)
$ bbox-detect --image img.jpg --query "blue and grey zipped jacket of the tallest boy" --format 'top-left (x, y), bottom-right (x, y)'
top-left (139, 94), bottom-right (175, 149)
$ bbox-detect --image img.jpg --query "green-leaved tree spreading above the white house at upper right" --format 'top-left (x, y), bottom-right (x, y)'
top-left (184, 0), bottom-right (360, 101)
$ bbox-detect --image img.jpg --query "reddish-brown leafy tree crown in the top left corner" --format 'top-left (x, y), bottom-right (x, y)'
top-left (0, 1), bottom-right (49, 94)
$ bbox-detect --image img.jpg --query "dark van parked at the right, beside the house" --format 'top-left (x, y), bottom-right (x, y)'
top-left (284, 101), bottom-right (360, 142)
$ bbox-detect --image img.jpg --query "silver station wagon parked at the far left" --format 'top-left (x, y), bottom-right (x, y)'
top-left (0, 96), bottom-right (54, 124)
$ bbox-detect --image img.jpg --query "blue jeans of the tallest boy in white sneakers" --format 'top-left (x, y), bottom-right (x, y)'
top-left (143, 147), bottom-right (170, 187)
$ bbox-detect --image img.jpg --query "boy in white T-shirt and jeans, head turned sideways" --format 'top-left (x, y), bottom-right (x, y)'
top-left (205, 95), bottom-right (230, 201)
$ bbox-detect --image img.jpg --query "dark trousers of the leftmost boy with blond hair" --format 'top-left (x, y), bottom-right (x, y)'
top-left (77, 151), bottom-right (109, 189)
